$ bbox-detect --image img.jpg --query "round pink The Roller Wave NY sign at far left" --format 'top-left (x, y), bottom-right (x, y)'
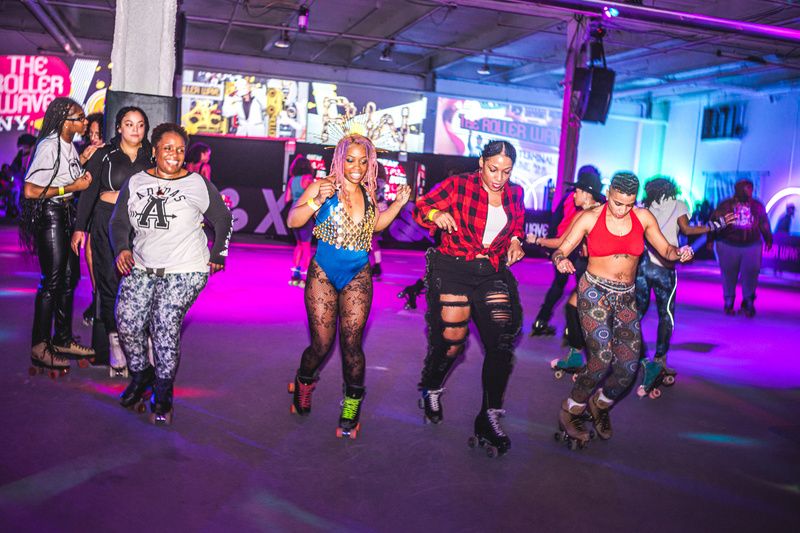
top-left (0, 56), bottom-right (71, 132)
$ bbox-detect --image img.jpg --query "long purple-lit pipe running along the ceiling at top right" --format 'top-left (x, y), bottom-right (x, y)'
top-left (438, 0), bottom-right (800, 43)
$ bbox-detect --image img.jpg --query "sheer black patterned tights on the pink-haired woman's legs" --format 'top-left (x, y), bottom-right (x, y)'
top-left (297, 260), bottom-right (372, 387)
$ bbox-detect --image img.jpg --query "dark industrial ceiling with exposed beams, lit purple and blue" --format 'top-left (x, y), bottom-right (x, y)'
top-left (0, 0), bottom-right (800, 98)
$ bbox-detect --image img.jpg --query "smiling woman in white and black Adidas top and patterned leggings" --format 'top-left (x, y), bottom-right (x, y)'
top-left (111, 123), bottom-right (232, 424)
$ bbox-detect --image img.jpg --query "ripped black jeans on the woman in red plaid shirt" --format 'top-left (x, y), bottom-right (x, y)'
top-left (419, 249), bottom-right (522, 410)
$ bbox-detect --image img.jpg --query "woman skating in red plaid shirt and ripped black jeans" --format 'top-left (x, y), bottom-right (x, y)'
top-left (414, 141), bottom-right (525, 455)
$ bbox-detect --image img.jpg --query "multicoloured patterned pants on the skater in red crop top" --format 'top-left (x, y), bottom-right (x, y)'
top-left (571, 272), bottom-right (642, 403)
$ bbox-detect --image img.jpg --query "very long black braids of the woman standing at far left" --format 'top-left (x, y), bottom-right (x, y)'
top-left (19, 98), bottom-right (81, 254)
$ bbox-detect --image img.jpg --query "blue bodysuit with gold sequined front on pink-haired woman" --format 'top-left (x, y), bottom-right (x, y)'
top-left (314, 187), bottom-right (375, 292)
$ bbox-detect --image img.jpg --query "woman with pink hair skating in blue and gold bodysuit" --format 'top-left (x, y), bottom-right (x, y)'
top-left (287, 135), bottom-right (411, 439)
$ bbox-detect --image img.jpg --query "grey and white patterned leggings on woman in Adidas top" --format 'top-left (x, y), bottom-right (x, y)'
top-left (116, 268), bottom-right (208, 380)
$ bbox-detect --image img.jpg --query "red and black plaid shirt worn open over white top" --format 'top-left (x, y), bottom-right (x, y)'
top-left (414, 172), bottom-right (525, 270)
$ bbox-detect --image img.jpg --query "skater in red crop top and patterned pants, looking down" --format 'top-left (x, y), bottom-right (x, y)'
top-left (552, 172), bottom-right (694, 447)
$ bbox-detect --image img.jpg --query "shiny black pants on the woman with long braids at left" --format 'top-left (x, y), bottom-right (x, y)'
top-left (31, 200), bottom-right (81, 346)
